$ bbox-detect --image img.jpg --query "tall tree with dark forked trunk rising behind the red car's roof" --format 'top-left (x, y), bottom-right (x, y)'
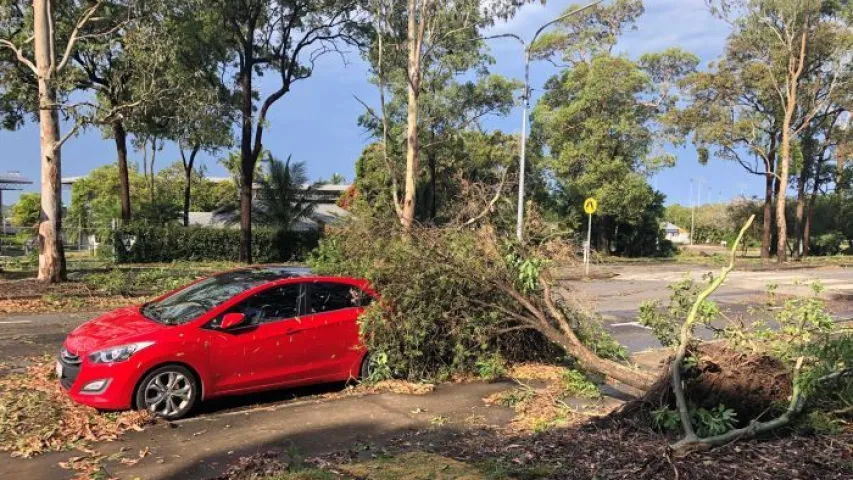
top-left (207, 0), bottom-right (364, 262)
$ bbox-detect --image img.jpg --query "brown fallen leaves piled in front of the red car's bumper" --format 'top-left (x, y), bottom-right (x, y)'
top-left (0, 356), bottom-right (152, 457)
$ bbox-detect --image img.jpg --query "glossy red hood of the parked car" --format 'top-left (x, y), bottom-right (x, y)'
top-left (65, 307), bottom-right (168, 355)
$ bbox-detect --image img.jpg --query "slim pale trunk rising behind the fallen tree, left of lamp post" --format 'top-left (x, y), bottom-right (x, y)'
top-left (400, 0), bottom-right (426, 232)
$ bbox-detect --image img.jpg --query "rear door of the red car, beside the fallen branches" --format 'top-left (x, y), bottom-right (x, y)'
top-left (296, 281), bottom-right (370, 380)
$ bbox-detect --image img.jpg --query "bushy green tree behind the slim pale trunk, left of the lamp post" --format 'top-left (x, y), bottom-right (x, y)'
top-left (357, 32), bottom-right (520, 222)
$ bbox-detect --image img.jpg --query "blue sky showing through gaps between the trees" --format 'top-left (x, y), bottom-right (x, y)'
top-left (0, 0), bottom-right (752, 204)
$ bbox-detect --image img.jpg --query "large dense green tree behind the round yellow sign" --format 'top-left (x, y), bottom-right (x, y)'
top-left (532, 0), bottom-right (698, 253)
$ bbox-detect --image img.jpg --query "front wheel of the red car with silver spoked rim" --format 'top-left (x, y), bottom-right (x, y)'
top-left (136, 365), bottom-right (201, 420)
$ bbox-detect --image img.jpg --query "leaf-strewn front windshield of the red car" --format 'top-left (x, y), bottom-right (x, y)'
top-left (141, 267), bottom-right (307, 325)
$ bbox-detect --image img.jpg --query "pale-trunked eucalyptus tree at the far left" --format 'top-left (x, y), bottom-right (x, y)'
top-left (0, 0), bottom-right (123, 282)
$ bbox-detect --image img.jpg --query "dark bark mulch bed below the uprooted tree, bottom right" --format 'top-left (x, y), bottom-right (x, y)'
top-left (440, 426), bottom-right (853, 480)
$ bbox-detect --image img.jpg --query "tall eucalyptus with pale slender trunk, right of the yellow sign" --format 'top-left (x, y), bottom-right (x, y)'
top-left (706, 0), bottom-right (850, 262)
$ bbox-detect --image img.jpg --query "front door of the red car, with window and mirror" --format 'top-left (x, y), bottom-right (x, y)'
top-left (203, 283), bottom-right (309, 393)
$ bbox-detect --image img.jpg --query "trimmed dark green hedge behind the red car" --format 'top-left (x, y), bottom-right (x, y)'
top-left (114, 226), bottom-right (320, 263)
